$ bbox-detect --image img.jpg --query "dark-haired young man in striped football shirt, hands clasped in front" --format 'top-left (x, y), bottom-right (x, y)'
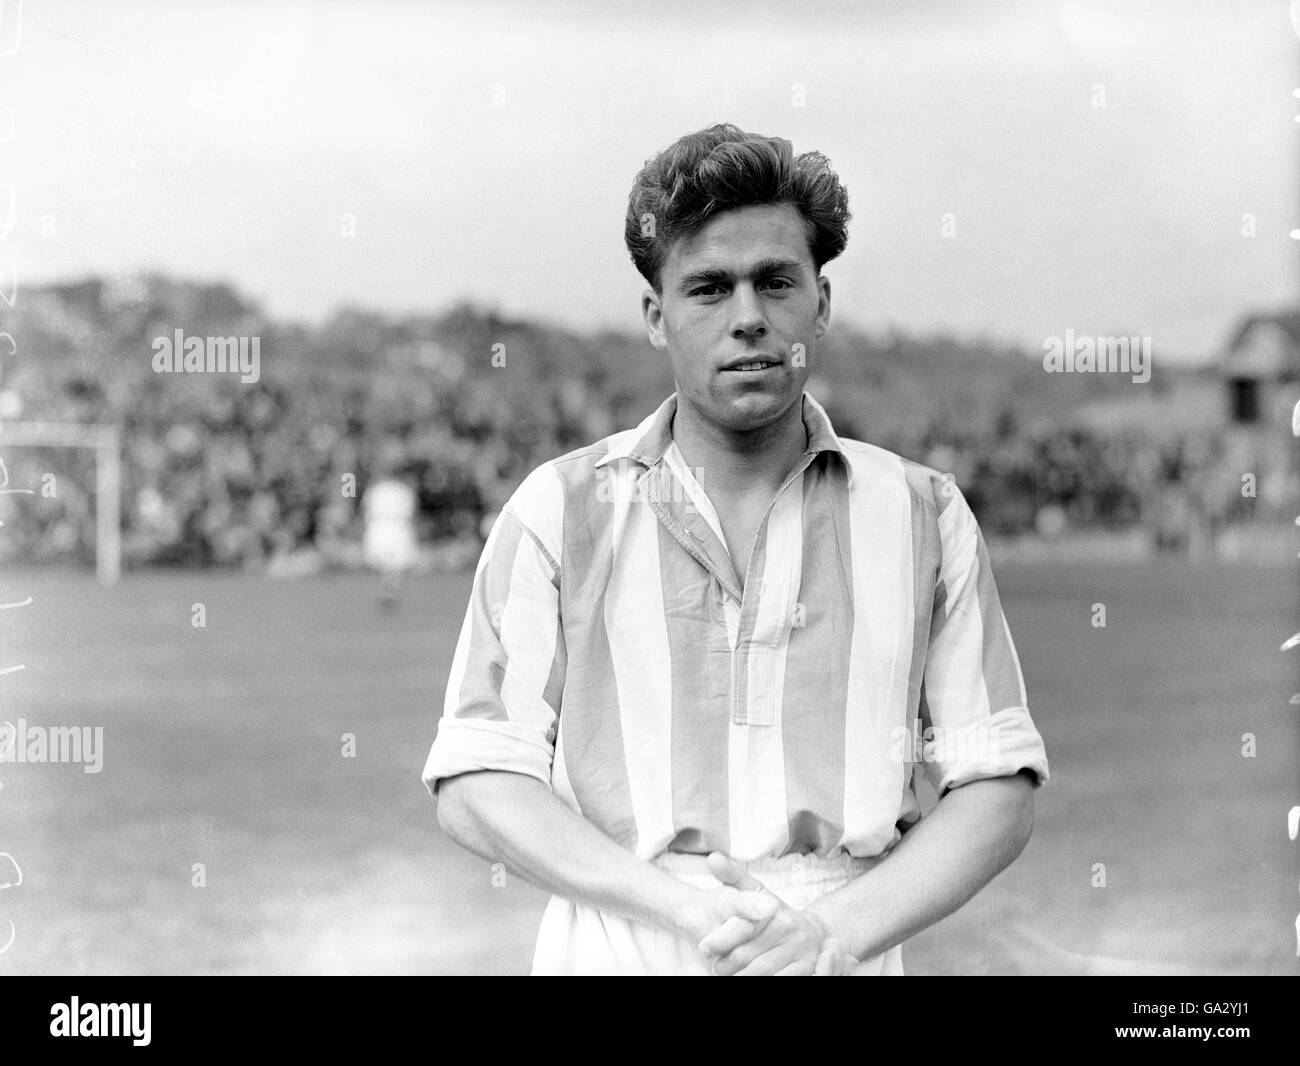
top-left (424, 126), bottom-right (1048, 975)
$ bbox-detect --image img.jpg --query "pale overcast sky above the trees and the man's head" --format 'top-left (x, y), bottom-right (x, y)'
top-left (0, 0), bottom-right (1300, 356)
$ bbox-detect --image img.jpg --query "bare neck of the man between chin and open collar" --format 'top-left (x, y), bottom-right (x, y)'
top-left (672, 393), bottom-right (807, 494)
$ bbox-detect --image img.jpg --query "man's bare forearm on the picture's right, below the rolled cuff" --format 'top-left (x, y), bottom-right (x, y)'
top-left (809, 774), bottom-right (1034, 959)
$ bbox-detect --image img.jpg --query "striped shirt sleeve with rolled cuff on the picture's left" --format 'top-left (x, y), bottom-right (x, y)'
top-left (423, 473), bottom-right (564, 794)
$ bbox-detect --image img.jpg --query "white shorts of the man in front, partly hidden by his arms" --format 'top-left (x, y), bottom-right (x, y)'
top-left (533, 852), bottom-right (902, 976)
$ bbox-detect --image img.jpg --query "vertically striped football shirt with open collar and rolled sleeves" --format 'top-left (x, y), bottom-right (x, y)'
top-left (424, 393), bottom-right (1048, 862)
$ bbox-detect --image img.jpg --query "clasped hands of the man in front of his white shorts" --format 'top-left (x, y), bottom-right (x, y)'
top-left (685, 852), bottom-right (858, 978)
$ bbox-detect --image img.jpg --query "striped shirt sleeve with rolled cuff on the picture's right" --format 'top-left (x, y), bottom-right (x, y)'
top-left (920, 482), bottom-right (1048, 796)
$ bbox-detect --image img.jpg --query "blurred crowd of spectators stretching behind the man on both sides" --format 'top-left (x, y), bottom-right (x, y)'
top-left (7, 372), bottom-right (1279, 569)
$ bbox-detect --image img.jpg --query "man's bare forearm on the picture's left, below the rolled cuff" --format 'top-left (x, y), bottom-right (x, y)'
top-left (438, 771), bottom-right (699, 932)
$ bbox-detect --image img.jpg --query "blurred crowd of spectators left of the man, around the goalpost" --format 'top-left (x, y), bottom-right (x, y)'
top-left (4, 351), bottom-right (614, 569)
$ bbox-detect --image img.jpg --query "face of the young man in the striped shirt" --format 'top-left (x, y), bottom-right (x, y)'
top-left (642, 204), bottom-right (831, 432)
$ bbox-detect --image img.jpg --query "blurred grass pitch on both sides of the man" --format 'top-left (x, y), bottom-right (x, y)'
top-left (0, 560), bottom-right (1300, 975)
